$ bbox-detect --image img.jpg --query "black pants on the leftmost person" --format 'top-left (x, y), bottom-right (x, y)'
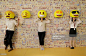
top-left (4, 30), bottom-right (14, 48)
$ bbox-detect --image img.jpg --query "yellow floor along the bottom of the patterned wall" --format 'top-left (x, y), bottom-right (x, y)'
top-left (0, 47), bottom-right (86, 56)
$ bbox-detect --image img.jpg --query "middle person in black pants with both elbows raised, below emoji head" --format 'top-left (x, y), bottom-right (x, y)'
top-left (34, 18), bottom-right (50, 50)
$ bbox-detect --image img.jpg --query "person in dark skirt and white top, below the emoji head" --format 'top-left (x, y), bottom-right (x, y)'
top-left (69, 17), bottom-right (81, 49)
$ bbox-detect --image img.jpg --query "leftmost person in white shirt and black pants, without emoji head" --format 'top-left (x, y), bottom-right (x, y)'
top-left (4, 18), bottom-right (19, 52)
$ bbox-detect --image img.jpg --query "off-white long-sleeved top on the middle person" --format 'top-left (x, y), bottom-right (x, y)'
top-left (34, 19), bottom-right (50, 32)
